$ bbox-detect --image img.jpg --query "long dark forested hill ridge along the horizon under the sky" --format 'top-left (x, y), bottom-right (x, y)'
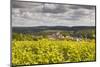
top-left (12, 26), bottom-right (96, 33)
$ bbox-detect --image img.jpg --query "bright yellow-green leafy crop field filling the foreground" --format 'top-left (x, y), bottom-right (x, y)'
top-left (12, 38), bottom-right (96, 65)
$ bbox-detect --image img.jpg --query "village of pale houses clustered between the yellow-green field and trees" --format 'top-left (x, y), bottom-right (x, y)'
top-left (32, 32), bottom-right (82, 41)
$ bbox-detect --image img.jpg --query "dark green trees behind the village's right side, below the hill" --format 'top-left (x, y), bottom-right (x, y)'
top-left (62, 30), bottom-right (96, 39)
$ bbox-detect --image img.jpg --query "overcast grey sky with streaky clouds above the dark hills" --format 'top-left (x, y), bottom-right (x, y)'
top-left (12, 0), bottom-right (95, 27)
